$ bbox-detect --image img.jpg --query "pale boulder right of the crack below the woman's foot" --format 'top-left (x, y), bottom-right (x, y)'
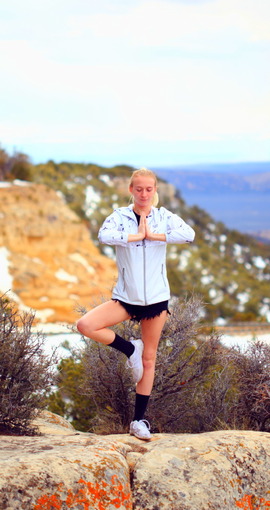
top-left (126, 431), bottom-right (270, 510)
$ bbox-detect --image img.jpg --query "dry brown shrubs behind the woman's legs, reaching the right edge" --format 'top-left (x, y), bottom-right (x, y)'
top-left (57, 296), bottom-right (270, 434)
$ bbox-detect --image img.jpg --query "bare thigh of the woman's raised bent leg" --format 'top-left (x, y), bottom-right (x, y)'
top-left (78, 300), bottom-right (130, 331)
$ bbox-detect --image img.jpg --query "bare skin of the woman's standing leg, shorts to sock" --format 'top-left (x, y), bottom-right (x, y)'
top-left (136, 310), bottom-right (168, 395)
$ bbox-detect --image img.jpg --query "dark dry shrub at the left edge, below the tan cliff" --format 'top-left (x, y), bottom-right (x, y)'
top-left (0, 296), bottom-right (55, 434)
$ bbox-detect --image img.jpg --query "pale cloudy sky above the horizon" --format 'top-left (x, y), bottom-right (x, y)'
top-left (0, 0), bottom-right (270, 168)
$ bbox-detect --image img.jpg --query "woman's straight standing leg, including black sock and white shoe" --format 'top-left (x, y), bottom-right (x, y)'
top-left (130, 311), bottom-right (167, 439)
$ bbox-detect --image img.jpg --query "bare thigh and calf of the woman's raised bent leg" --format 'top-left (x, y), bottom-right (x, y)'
top-left (77, 300), bottom-right (130, 345)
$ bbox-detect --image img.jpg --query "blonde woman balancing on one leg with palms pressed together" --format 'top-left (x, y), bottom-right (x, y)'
top-left (77, 168), bottom-right (195, 440)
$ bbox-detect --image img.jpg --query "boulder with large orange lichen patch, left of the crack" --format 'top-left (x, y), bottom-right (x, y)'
top-left (0, 433), bottom-right (132, 510)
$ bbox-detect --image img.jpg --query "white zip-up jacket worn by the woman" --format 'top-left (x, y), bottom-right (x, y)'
top-left (98, 205), bottom-right (195, 306)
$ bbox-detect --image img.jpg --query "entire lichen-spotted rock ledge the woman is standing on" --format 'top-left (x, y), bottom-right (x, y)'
top-left (0, 412), bottom-right (270, 510)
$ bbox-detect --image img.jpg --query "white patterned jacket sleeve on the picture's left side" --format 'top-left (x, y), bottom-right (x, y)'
top-left (98, 211), bottom-right (128, 246)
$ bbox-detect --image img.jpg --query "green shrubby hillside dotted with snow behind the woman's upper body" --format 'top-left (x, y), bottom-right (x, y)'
top-left (2, 161), bottom-right (270, 321)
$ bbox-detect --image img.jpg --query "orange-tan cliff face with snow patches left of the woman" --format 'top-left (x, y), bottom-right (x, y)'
top-left (0, 183), bottom-right (116, 323)
